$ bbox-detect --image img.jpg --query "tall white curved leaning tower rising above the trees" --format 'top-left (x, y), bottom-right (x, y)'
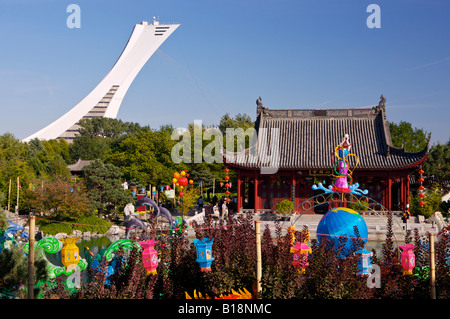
top-left (23, 19), bottom-right (180, 143)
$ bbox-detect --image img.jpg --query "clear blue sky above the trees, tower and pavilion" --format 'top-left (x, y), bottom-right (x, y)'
top-left (0, 0), bottom-right (450, 143)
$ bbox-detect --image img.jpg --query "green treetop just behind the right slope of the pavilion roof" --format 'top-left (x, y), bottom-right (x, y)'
top-left (389, 121), bottom-right (431, 152)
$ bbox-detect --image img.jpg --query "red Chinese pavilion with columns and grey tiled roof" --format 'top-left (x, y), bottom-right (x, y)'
top-left (224, 96), bottom-right (429, 213)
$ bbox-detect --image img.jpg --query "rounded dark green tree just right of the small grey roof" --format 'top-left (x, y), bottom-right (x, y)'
top-left (83, 160), bottom-right (132, 217)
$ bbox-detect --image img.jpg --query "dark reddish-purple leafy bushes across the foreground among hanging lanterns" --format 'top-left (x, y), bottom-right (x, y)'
top-left (39, 213), bottom-right (450, 299)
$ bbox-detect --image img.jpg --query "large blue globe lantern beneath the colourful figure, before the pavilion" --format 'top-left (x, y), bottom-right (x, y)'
top-left (316, 207), bottom-right (369, 257)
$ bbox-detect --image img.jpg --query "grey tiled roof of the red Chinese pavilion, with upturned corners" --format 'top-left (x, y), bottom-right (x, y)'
top-left (224, 97), bottom-right (429, 170)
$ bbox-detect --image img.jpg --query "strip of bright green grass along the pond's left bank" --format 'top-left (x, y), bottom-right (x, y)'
top-left (36, 216), bottom-right (112, 235)
